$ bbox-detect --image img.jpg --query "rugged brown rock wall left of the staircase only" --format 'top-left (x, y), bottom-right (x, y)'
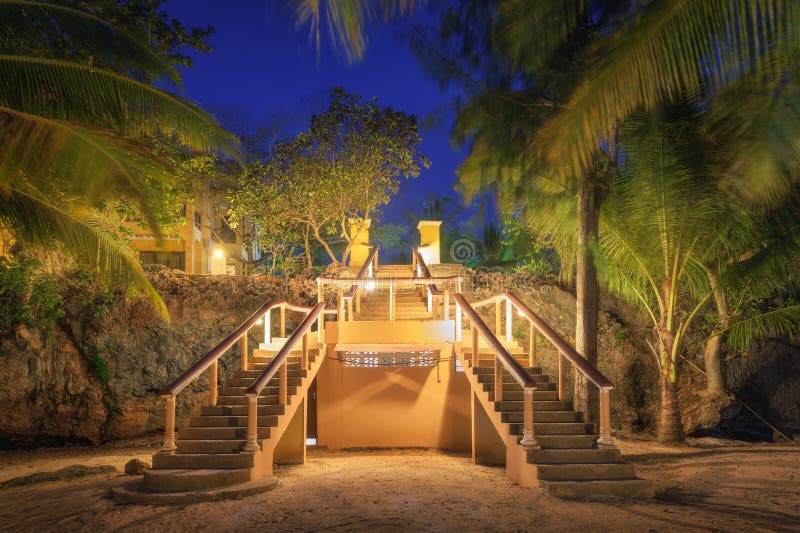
top-left (0, 271), bottom-right (316, 447)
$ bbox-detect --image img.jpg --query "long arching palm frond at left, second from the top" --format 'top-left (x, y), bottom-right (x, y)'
top-left (0, 55), bottom-right (236, 154)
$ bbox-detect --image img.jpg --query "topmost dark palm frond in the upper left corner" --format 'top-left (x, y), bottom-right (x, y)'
top-left (0, 0), bottom-right (180, 84)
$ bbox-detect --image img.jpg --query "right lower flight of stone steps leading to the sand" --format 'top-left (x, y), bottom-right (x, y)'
top-left (461, 331), bottom-right (654, 498)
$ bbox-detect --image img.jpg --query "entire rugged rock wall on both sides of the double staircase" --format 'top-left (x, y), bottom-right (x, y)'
top-left (0, 271), bottom-right (800, 447)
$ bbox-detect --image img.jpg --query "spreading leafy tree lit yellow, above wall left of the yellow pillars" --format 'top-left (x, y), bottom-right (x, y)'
top-left (234, 89), bottom-right (429, 264)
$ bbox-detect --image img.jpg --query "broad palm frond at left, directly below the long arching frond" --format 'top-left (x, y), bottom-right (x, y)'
top-left (0, 107), bottom-right (165, 232)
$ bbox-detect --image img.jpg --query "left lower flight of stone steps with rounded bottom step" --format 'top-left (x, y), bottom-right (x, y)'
top-left (117, 344), bottom-right (321, 503)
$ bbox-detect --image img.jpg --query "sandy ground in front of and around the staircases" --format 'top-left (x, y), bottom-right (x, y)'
top-left (0, 439), bottom-right (800, 532)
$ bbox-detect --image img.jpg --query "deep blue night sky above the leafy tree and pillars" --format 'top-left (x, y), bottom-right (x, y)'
top-left (164, 0), bottom-right (472, 227)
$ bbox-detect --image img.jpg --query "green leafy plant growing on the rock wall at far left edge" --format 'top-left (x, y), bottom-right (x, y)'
top-left (0, 257), bottom-right (64, 336)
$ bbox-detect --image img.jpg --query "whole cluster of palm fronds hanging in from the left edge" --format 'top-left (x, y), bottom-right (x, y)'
top-left (0, 0), bottom-right (235, 316)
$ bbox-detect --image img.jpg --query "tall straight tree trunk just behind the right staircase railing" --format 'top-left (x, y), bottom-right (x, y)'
top-left (573, 179), bottom-right (600, 423)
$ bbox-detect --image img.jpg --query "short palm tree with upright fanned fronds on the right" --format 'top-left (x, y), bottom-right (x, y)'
top-left (598, 115), bottom-right (800, 442)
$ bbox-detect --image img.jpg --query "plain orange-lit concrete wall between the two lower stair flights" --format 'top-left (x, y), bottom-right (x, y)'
top-left (317, 359), bottom-right (471, 451)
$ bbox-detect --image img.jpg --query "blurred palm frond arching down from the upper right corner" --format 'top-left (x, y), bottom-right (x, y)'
top-left (534, 0), bottom-right (800, 175)
